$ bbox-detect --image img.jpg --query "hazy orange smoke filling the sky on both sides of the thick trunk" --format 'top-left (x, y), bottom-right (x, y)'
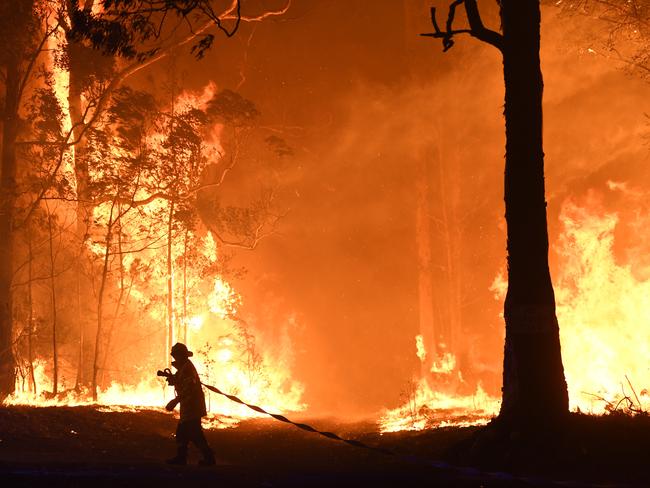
top-left (133, 0), bottom-right (648, 413)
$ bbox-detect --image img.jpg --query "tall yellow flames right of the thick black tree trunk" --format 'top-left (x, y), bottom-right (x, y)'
top-left (555, 198), bottom-right (650, 414)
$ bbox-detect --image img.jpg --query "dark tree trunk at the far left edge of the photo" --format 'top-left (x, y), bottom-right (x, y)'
top-left (0, 58), bottom-right (20, 400)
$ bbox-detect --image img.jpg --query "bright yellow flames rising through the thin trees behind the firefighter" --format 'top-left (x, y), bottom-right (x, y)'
top-left (7, 43), bottom-right (306, 428)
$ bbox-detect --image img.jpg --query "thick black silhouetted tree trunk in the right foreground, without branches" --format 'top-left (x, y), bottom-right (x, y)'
top-left (499, 0), bottom-right (568, 426)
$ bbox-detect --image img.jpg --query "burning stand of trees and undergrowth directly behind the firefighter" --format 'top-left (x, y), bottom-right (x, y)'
top-left (7, 16), bottom-right (305, 425)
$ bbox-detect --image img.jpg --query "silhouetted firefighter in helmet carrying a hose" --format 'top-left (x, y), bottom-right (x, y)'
top-left (165, 342), bottom-right (215, 466)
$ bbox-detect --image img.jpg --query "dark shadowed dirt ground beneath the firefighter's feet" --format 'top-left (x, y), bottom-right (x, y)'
top-left (0, 406), bottom-right (650, 488)
